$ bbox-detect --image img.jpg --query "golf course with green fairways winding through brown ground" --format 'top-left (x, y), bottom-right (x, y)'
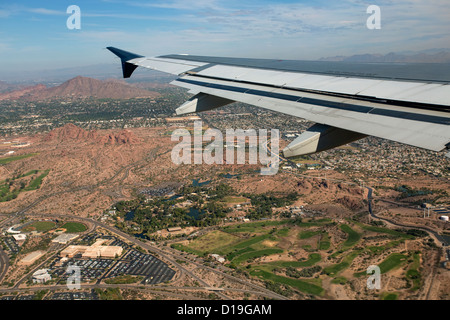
top-left (173, 218), bottom-right (421, 300)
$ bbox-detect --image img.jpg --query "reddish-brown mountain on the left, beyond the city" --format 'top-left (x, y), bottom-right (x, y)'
top-left (0, 76), bottom-right (160, 101)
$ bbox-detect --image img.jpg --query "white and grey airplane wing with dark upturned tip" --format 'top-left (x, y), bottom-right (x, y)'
top-left (108, 47), bottom-right (450, 157)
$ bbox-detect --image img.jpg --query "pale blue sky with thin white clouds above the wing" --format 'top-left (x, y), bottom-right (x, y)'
top-left (0, 0), bottom-right (450, 72)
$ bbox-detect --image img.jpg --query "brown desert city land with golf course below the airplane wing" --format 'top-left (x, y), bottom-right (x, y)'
top-left (0, 69), bottom-right (450, 300)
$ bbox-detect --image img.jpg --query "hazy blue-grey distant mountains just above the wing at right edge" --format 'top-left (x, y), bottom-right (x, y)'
top-left (319, 50), bottom-right (450, 63)
